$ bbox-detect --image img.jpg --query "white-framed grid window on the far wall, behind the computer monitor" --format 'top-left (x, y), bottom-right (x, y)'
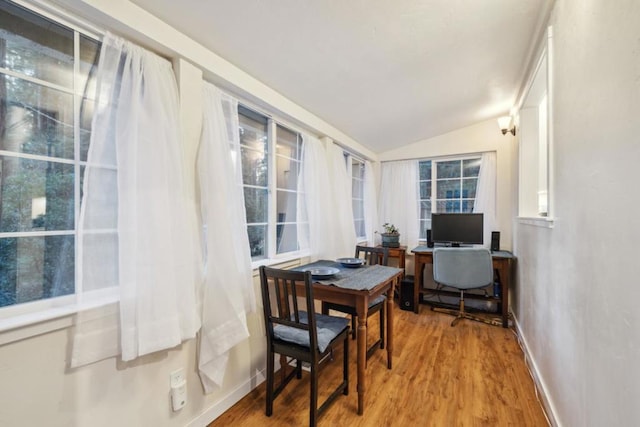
top-left (418, 157), bottom-right (481, 240)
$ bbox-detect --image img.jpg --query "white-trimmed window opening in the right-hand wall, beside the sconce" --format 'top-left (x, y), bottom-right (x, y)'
top-left (518, 29), bottom-right (551, 218)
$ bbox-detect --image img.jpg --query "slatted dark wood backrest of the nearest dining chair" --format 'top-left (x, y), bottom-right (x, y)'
top-left (260, 266), bottom-right (318, 353)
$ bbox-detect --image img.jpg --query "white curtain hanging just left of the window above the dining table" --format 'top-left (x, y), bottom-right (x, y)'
top-left (197, 83), bottom-right (256, 393)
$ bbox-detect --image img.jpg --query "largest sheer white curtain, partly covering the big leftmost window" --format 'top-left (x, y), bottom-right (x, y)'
top-left (72, 34), bottom-right (200, 366)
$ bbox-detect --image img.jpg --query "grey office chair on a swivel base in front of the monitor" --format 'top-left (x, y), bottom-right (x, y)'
top-left (432, 248), bottom-right (501, 326)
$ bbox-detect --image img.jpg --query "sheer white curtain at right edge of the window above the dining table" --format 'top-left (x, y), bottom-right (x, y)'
top-left (297, 134), bottom-right (335, 261)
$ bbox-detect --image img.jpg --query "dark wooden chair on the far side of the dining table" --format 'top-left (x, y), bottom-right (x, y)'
top-left (322, 246), bottom-right (389, 359)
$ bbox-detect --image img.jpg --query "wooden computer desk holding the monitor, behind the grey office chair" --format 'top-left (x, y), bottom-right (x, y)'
top-left (411, 246), bottom-right (516, 328)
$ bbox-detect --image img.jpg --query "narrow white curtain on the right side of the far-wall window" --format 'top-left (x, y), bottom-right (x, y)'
top-left (473, 151), bottom-right (497, 248)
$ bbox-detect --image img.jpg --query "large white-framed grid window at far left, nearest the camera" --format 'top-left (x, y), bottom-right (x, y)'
top-left (0, 1), bottom-right (100, 317)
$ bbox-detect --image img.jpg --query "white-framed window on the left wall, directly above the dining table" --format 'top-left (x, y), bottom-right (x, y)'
top-left (238, 106), bottom-right (302, 261)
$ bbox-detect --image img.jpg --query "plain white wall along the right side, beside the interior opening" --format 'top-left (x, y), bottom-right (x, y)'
top-left (512, 0), bottom-right (640, 426)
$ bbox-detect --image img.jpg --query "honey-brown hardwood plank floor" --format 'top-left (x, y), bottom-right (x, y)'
top-left (209, 305), bottom-right (548, 427)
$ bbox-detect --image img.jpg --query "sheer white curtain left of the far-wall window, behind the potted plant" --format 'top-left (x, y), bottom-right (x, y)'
top-left (378, 160), bottom-right (420, 248)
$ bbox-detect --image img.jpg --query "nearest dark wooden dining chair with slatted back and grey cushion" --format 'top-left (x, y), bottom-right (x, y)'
top-left (260, 266), bottom-right (349, 426)
